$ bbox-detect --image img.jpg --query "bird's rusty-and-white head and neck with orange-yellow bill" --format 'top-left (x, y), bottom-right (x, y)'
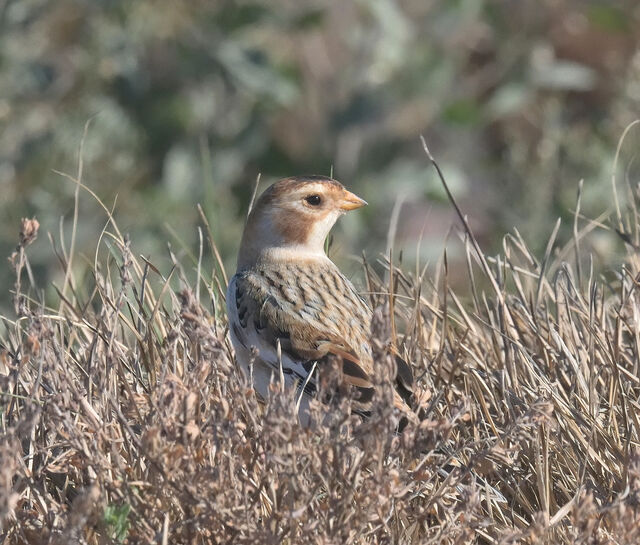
top-left (238, 176), bottom-right (367, 270)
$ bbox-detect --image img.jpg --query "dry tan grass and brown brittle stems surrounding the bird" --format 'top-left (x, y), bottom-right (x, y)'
top-left (0, 142), bottom-right (640, 544)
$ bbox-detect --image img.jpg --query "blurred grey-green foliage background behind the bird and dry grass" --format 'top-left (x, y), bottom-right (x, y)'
top-left (0, 0), bottom-right (640, 308)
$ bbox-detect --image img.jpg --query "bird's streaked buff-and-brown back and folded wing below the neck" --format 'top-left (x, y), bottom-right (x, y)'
top-left (227, 264), bottom-right (407, 410)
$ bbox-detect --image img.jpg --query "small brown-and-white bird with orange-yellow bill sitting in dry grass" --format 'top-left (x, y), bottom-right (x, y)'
top-left (227, 176), bottom-right (411, 425)
